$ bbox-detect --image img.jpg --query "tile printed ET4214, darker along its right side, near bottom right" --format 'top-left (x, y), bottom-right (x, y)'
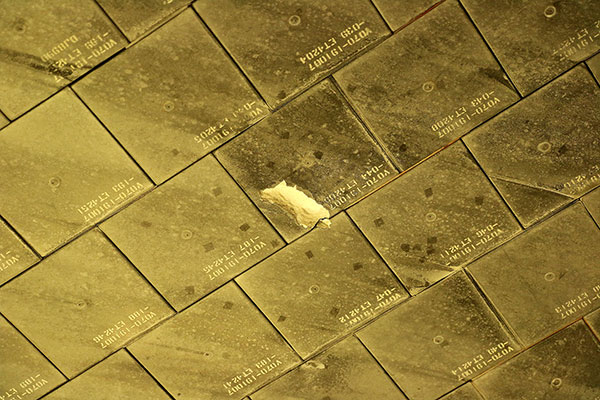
top-left (358, 271), bottom-right (518, 400)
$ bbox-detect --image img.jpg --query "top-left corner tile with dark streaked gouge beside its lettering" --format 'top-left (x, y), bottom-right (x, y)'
top-left (0, 0), bottom-right (127, 119)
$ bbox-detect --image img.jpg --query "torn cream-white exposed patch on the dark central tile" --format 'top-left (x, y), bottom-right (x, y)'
top-left (260, 181), bottom-right (331, 228)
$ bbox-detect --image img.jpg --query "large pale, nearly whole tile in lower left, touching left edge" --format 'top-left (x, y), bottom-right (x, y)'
top-left (0, 230), bottom-right (172, 377)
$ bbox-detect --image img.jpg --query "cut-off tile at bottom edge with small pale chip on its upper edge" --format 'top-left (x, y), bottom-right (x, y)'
top-left (252, 336), bottom-right (406, 400)
